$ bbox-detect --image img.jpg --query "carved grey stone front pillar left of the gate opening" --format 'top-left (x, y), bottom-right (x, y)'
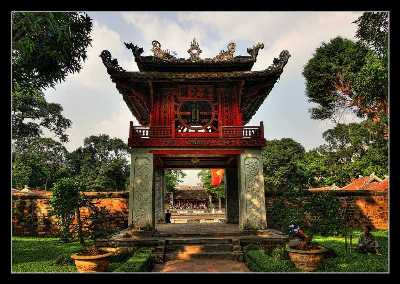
top-left (128, 149), bottom-right (155, 229)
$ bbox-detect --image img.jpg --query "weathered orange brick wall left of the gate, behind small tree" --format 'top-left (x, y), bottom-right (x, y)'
top-left (12, 190), bottom-right (128, 236)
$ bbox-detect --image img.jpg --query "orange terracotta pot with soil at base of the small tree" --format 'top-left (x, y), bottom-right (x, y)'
top-left (71, 246), bottom-right (114, 272)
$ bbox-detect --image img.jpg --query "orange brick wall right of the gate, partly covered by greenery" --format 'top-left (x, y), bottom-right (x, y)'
top-left (266, 190), bottom-right (389, 230)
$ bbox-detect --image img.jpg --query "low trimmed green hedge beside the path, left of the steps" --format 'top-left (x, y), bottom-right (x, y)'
top-left (114, 248), bottom-right (153, 272)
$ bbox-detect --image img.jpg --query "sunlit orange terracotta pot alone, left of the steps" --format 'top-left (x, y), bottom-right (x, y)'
top-left (71, 252), bottom-right (114, 272)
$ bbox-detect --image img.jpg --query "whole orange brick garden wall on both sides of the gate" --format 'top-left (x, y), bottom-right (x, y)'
top-left (12, 187), bottom-right (388, 236)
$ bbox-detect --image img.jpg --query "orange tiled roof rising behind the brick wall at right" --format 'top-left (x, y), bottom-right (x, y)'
top-left (309, 174), bottom-right (389, 191)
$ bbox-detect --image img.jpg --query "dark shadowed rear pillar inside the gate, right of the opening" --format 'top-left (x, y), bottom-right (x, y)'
top-left (225, 168), bottom-right (239, 224)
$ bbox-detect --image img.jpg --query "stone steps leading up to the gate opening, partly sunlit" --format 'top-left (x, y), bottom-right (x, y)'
top-left (153, 238), bottom-right (243, 263)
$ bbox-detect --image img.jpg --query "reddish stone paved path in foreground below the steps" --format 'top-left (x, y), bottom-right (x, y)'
top-left (153, 259), bottom-right (249, 272)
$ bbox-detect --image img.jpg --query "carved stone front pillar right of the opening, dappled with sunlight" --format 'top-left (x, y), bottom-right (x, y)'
top-left (239, 150), bottom-right (267, 230)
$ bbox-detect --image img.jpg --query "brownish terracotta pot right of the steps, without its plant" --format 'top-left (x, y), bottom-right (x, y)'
top-left (287, 247), bottom-right (328, 272)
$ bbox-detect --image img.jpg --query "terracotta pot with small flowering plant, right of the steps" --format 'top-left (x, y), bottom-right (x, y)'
top-left (287, 225), bottom-right (328, 272)
